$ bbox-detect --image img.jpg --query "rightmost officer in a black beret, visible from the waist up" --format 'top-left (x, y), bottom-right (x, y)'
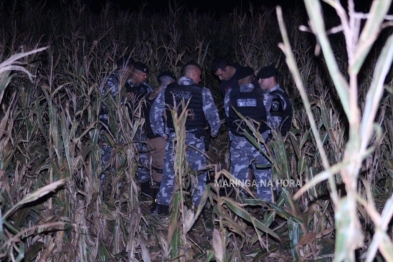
top-left (257, 65), bottom-right (293, 137)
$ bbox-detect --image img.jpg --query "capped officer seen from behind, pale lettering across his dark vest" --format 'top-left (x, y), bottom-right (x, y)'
top-left (224, 67), bottom-right (271, 201)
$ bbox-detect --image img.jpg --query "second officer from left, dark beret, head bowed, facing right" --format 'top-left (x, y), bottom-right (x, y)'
top-left (125, 62), bottom-right (153, 197)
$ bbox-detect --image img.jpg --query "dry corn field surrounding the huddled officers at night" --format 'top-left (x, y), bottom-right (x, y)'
top-left (0, 0), bottom-right (393, 262)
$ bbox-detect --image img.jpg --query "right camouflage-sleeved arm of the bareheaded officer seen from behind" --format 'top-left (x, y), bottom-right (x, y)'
top-left (202, 87), bottom-right (221, 136)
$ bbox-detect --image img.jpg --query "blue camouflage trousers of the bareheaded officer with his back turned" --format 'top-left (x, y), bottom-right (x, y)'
top-left (157, 133), bottom-right (207, 206)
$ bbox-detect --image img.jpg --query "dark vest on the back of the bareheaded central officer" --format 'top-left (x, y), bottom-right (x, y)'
top-left (165, 83), bottom-right (206, 130)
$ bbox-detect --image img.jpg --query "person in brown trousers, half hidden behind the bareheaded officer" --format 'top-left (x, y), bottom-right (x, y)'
top-left (142, 71), bottom-right (176, 210)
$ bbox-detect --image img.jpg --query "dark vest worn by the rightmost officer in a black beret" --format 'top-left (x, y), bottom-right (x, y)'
top-left (269, 90), bottom-right (293, 136)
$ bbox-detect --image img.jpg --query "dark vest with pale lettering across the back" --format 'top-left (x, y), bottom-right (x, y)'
top-left (227, 88), bottom-right (268, 136)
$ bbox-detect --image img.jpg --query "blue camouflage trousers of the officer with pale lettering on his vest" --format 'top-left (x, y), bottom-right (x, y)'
top-left (229, 133), bottom-right (272, 201)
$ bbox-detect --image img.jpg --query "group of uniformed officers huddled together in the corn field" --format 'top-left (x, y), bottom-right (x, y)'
top-left (100, 57), bottom-right (292, 215)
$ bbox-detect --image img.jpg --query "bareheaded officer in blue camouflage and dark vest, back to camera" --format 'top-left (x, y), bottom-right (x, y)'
top-left (150, 62), bottom-right (221, 214)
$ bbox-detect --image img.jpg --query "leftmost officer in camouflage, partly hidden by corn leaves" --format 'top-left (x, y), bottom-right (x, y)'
top-left (99, 55), bottom-right (134, 199)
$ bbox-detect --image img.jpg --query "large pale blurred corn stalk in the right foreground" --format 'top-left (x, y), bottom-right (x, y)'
top-left (277, 0), bottom-right (393, 261)
